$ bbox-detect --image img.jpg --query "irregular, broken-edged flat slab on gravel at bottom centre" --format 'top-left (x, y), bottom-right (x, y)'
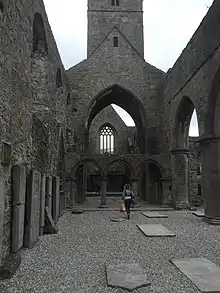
top-left (106, 263), bottom-right (150, 292)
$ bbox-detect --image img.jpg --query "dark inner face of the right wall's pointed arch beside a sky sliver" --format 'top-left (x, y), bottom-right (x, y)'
top-left (172, 96), bottom-right (199, 149)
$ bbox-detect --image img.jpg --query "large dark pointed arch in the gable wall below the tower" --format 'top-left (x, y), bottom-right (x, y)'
top-left (84, 84), bottom-right (146, 153)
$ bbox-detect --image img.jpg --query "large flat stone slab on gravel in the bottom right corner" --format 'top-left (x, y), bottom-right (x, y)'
top-left (171, 258), bottom-right (220, 293)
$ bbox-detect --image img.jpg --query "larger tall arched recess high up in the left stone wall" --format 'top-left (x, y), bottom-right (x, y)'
top-left (32, 12), bottom-right (48, 56)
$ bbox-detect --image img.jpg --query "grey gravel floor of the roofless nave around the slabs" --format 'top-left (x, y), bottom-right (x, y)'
top-left (0, 211), bottom-right (220, 293)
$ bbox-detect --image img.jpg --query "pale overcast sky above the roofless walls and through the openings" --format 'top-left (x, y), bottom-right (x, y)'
top-left (44, 0), bottom-right (213, 135)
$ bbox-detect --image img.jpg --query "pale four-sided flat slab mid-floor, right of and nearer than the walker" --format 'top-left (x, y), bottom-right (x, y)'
top-left (137, 224), bottom-right (176, 237)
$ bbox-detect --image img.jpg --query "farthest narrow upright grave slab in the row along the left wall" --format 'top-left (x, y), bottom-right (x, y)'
top-left (52, 176), bottom-right (60, 223)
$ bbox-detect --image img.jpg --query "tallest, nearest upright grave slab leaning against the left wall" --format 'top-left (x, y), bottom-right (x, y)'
top-left (12, 165), bottom-right (26, 253)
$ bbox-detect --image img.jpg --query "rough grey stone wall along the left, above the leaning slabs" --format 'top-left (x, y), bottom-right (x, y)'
top-left (0, 0), bottom-right (67, 264)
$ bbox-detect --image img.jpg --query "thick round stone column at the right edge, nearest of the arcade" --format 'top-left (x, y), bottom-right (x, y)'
top-left (200, 136), bottom-right (220, 225)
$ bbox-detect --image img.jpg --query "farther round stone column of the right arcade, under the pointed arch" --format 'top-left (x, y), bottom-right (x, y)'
top-left (171, 149), bottom-right (190, 210)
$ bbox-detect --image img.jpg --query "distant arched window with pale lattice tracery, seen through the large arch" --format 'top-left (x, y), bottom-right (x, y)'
top-left (99, 125), bottom-right (115, 154)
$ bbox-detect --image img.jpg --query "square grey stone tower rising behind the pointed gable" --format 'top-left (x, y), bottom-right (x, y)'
top-left (87, 0), bottom-right (144, 58)
